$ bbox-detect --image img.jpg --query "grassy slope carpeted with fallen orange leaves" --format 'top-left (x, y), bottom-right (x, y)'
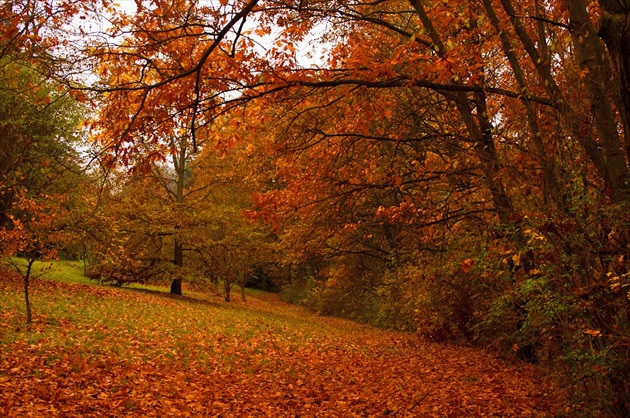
top-left (0, 262), bottom-right (565, 417)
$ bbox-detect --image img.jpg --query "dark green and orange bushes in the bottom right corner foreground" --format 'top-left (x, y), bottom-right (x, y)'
top-left (478, 201), bottom-right (630, 415)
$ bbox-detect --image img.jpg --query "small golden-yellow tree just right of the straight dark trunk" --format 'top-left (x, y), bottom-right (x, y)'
top-left (189, 133), bottom-right (276, 302)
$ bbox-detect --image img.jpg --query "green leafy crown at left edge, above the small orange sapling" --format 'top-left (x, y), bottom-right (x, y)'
top-left (0, 58), bottom-right (84, 226)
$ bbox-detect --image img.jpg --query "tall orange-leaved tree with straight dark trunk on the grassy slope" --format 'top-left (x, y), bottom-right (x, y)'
top-left (80, 1), bottom-right (262, 294)
